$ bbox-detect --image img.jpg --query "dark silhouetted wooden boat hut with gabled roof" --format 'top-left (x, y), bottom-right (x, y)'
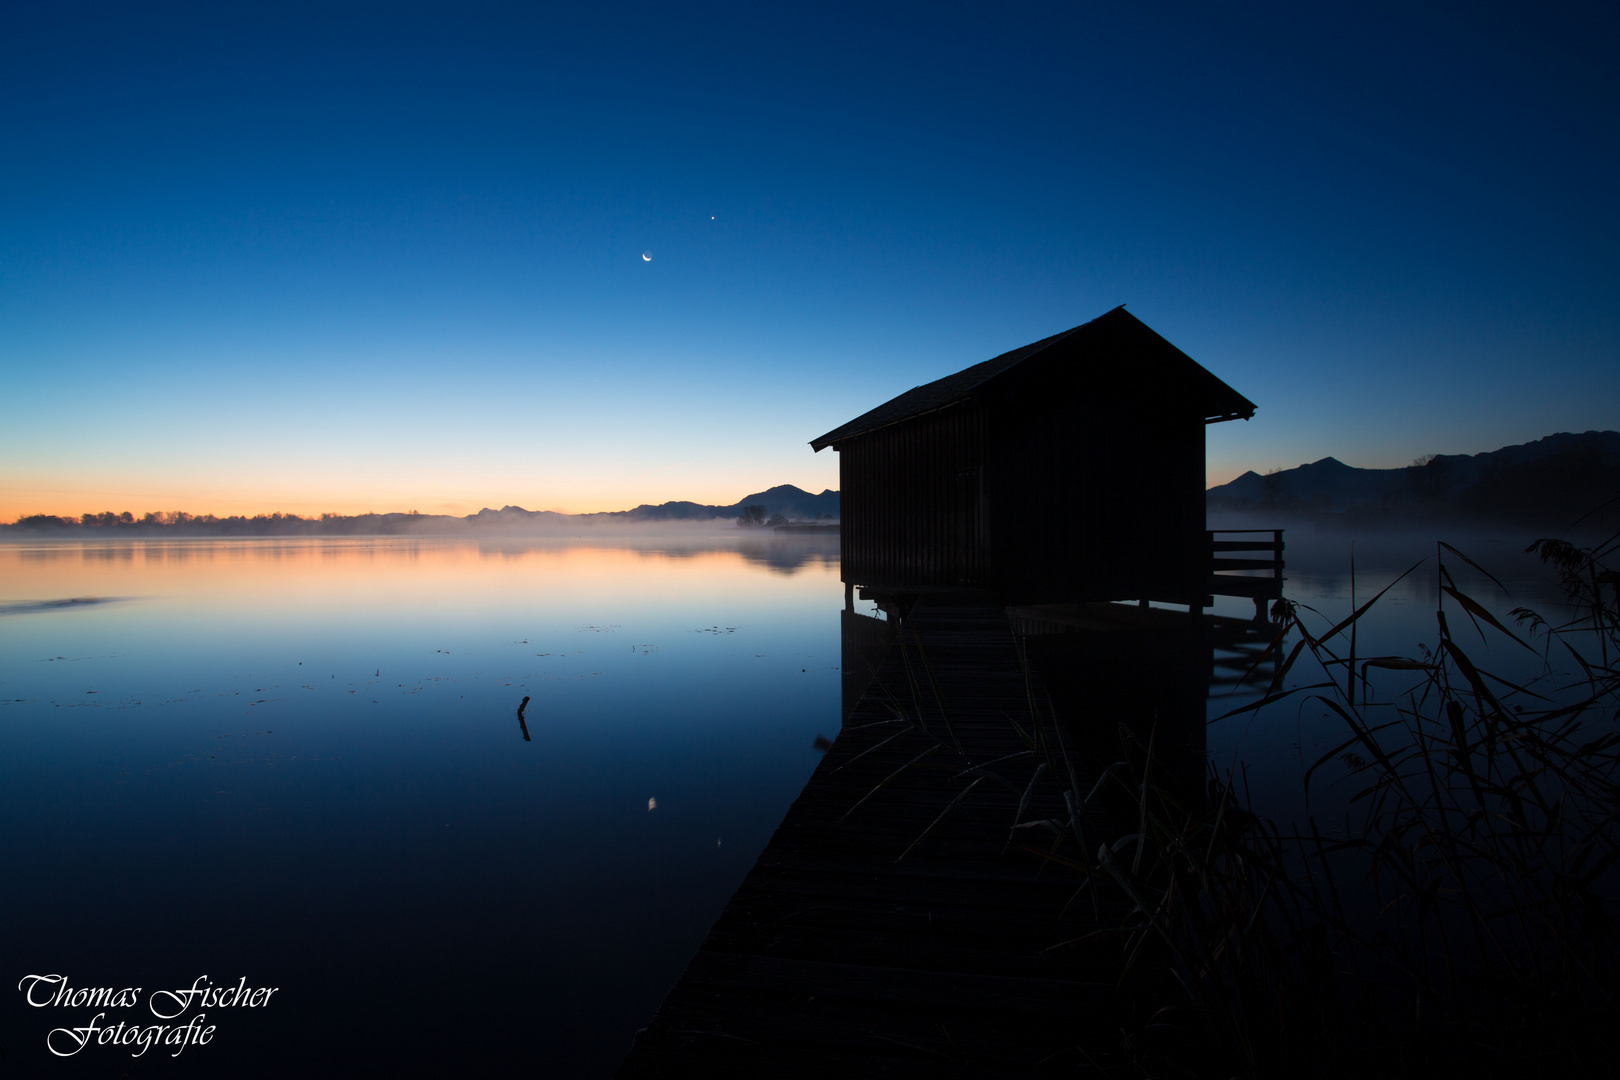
top-left (810, 308), bottom-right (1254, 607)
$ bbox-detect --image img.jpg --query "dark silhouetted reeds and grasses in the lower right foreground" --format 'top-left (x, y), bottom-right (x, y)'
top-left (862, 534), bottom-right (1620, 1077)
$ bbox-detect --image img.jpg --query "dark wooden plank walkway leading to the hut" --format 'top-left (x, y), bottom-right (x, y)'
top-left (617, 597), bottom-right (1128, 1080)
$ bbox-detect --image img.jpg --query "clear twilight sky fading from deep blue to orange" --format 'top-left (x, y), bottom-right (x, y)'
top-left (0, 0), bottom-right (1620, 520)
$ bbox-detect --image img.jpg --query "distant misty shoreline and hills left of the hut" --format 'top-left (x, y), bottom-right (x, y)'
top-left (9, 484), bottom-right (838, 536)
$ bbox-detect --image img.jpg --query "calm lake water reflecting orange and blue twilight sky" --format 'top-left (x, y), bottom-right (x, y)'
top-left (0, 533), bottom-right (1581, 1077)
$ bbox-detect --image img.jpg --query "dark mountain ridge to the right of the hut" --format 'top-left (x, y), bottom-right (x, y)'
top-left (1205, 431), bottom-right (1620, 525)
